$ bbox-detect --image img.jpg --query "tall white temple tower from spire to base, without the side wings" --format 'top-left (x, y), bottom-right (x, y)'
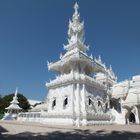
top-left (43, 3), bottom-right (115, 126)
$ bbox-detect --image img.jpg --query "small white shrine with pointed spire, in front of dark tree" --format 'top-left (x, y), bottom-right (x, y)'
top-left (2, 89), bottom-right (22, 120)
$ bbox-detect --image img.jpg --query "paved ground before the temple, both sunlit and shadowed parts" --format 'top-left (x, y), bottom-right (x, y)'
top-left (0, 121), bottom-right (140, 140)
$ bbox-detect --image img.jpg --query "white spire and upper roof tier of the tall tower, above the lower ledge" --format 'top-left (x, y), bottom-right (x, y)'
top-left (48, 3), bottom-right (105, 73)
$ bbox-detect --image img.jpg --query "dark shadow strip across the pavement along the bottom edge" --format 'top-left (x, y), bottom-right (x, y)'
top-left (0, 129), bottom-right (140, 140)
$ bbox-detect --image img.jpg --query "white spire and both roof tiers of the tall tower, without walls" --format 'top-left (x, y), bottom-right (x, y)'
top-left (46, 3), bottom-right (116, 89)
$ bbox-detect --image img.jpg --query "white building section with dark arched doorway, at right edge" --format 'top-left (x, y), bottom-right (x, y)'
top-left (110, 75), bottom-right (140, 124)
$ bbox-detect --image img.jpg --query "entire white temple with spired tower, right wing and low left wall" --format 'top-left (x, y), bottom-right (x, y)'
top-left (18, 3), bottom-right (140, 126)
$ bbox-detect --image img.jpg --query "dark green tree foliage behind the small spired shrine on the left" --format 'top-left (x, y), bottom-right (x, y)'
top-left (0, 93), bottom-right (30, 114)
